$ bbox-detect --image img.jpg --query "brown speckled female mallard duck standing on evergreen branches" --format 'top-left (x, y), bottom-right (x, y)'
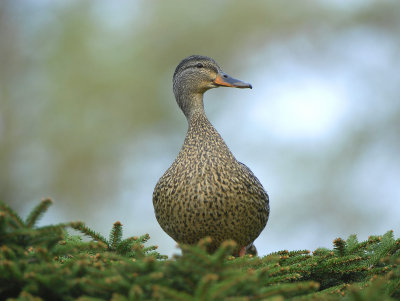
top-left (153, 55), bottom-right (269, 255)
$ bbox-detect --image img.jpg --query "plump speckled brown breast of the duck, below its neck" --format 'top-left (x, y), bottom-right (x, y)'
top-left (153, 151), bottom-right (269, 249)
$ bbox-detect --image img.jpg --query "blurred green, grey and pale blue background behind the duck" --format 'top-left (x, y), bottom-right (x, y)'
top-left (0, 0), bottom-right (400, 255)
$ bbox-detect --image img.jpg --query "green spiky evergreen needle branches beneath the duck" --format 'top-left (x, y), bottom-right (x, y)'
top-left (0, 199), bottom-right (400, 301)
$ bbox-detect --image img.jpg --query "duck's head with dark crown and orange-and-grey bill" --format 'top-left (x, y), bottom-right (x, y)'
top-left (173, 55), bottom-right (252, 117)
